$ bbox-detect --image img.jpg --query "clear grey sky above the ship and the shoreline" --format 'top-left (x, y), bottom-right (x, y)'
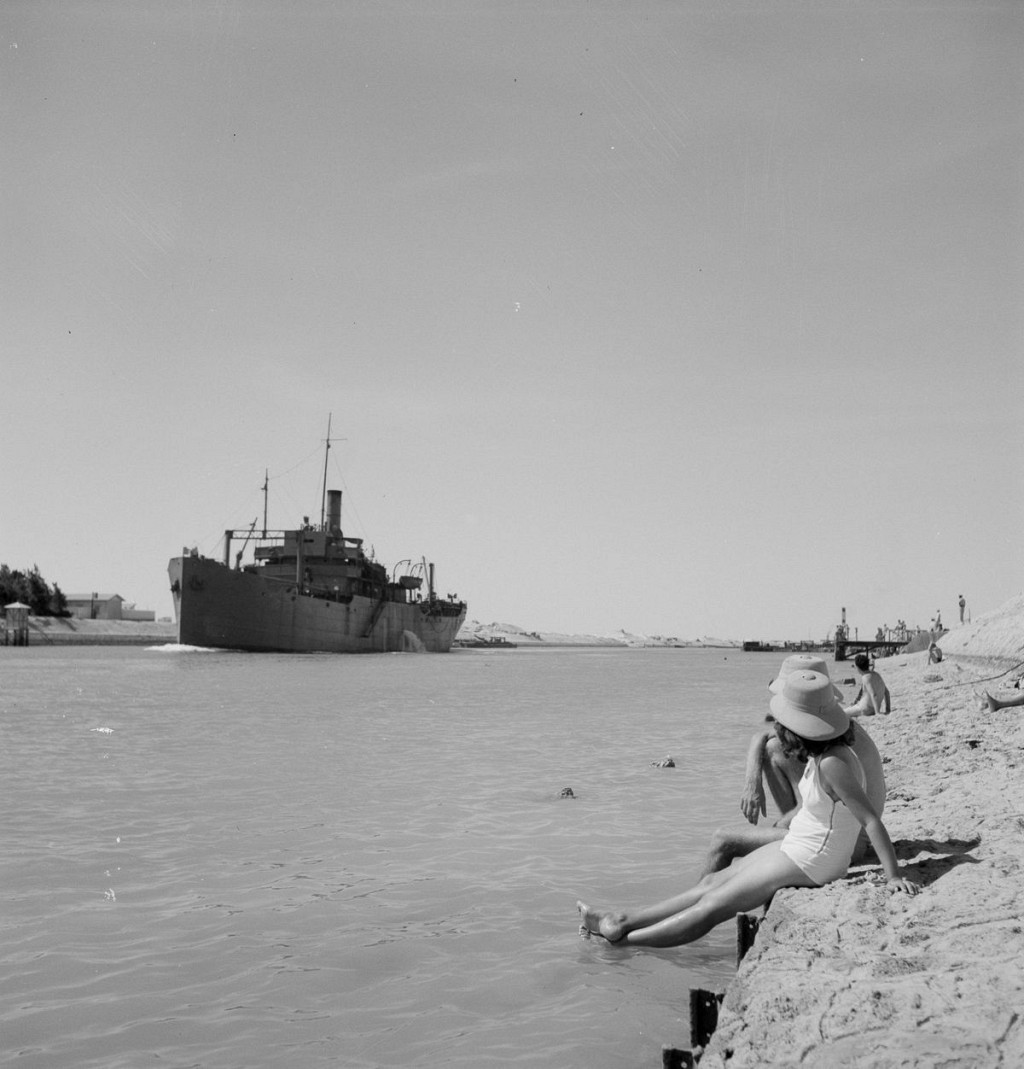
top-left (0, 0), bottom-right (1024, 639)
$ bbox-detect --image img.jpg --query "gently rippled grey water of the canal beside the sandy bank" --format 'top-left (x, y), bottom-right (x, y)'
top-left (0, 647), bottom-right (820, 1069)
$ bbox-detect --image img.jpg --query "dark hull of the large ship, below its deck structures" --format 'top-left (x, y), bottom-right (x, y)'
top-left (168, 556), bottom-right (466, 653)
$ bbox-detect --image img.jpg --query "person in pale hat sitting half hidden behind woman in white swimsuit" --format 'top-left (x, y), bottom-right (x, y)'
top-left (701, 653), bottom-right (886, 877)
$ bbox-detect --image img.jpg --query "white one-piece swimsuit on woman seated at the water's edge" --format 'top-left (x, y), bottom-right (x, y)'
top-left (779, 750), bottom-right (866, 886)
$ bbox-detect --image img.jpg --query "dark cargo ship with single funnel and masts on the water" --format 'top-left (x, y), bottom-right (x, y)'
top-left (168, 483), bottom-right (466, 653)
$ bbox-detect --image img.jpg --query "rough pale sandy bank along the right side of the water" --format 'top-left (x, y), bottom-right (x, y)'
top-left (700, 595), bottom-right (1024, 1069)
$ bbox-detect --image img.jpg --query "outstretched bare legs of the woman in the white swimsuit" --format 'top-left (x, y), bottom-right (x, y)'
top-left (576, 842), bottom-right (817, 947)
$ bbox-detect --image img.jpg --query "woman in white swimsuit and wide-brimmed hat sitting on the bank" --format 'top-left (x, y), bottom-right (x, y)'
top-left (576, 671), bottom-right (919, 947)
